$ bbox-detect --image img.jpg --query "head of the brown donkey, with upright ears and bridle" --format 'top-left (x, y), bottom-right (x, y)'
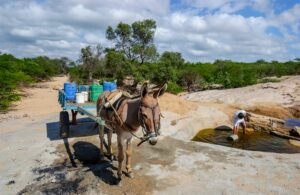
top-left (140, 83), bottom-right (167, 145)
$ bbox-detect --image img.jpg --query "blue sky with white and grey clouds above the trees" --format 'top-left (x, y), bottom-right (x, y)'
top-left (0, 0), bottom-right (300, 62)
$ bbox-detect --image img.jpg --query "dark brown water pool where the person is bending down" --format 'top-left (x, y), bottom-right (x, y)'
top-left (192, 129), bottom-right (300, 153)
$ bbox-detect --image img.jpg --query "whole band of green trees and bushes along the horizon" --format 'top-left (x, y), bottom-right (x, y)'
top-left (0, 19), bottom-right (300, 111)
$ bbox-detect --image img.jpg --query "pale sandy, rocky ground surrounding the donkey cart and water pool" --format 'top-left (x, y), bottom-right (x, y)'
top-left (0, 77), bottom-right (300, 194)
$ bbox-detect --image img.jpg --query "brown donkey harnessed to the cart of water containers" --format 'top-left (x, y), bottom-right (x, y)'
top-left (97, 83), bottom-right (167, 180)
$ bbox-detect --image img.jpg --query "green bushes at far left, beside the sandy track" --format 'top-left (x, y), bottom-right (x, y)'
top-left (0, 54), bottom-right (68, 112)
